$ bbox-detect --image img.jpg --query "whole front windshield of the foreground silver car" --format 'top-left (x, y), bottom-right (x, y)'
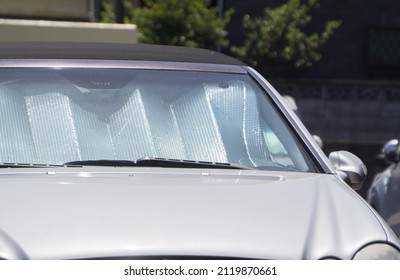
top-left (0, 68), bottom-right (316, 172)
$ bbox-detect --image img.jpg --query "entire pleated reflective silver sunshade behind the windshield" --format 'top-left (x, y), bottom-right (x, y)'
top-left (2, 76), bottom-right (274, 166)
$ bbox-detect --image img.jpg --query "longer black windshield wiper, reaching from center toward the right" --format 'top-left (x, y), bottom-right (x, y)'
top-left (64, 157), bottom-right (251, 169)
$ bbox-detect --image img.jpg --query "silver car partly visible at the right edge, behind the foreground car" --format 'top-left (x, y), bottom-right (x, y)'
top-left (367, 139), bottom-right (400, 237)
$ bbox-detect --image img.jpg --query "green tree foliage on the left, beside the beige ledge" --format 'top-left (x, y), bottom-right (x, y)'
top-left (102, 0), bottom-right (233, 49)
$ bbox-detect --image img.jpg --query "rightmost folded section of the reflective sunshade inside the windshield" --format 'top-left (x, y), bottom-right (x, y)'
top-left (205, 81), bottom-right (269, 166)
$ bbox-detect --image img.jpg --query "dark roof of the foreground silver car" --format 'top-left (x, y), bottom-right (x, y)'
top-left (0, 42), bottom-right (245, 65)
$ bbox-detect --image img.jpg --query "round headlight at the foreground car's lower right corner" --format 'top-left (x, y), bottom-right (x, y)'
top-left (353, 243), bottom-right (400, 260)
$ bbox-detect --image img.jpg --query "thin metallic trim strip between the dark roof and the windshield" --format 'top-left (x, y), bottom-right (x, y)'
top-left (0, 59), bottom-right (247, 74)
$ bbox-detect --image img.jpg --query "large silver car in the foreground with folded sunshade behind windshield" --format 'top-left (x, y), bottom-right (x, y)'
top-left (0, 43), bottom-right (400, 260)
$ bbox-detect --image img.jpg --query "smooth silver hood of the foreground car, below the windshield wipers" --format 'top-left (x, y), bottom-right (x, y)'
top-left (0, 167), bottom-right (387, 259)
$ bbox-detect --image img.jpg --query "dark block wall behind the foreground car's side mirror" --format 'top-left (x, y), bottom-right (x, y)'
top-left (272, 80), bottom-right (400, 197)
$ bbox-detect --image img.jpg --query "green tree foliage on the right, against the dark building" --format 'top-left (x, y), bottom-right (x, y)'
top-left (231, 0), bottom-right (341, 74)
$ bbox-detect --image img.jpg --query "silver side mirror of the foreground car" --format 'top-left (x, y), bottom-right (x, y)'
top-left (329, 151), bottom-right (367, 190)
